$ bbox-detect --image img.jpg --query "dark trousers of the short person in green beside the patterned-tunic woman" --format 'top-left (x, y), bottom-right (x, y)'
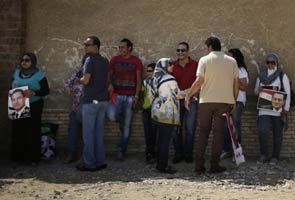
top-left (142, 109), bottom-right (157, 157)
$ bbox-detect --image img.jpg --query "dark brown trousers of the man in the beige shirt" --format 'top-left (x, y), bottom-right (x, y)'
top-left (196, 103), bottom-right (230, 170)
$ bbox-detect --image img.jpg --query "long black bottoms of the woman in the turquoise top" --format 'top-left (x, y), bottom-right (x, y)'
top-left (11, 100), bottom-right (44, 163)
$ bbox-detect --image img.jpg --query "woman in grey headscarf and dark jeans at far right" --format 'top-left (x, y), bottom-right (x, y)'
top-left (254, 53), bottom-right (291, 165)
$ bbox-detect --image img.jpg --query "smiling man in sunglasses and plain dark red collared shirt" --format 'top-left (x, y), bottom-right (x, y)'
top-left (172, 42), bottom-right (198, 163)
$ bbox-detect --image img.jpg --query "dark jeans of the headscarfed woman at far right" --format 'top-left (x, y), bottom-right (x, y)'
top-left (258, 115), bottom-right (283, 159)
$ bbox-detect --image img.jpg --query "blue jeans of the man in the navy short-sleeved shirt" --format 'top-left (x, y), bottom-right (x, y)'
top-left (82, 101), bottom-right (108, 169)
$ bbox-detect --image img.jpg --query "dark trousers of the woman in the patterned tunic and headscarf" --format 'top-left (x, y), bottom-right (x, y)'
top-left (157, 123), bottom-right (175, 170)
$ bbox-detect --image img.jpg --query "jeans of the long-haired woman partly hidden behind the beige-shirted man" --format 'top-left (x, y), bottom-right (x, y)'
top-left (223, 102), bottom-right (245, 152)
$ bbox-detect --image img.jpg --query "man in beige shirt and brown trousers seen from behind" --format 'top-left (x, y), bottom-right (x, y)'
top-left (185, 37), bottom-right (239, 174)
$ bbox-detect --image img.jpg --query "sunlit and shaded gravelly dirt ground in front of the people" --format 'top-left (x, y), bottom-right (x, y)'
top-left (0, 154), bottom-right (295, 200)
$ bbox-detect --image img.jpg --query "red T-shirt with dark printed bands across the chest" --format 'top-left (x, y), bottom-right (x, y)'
top-left (110, 56), bottom-right (143, 95)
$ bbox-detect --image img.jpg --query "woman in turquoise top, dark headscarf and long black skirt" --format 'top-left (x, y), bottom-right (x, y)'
top-left (11, 53), bottom-right (49, 165)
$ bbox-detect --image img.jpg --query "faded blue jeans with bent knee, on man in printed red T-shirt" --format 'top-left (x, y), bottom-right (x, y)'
top-left (107, 94), bottom-right (134, 153)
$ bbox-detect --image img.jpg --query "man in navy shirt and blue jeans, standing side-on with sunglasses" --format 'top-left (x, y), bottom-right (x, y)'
top-left (76, 36), bottom-right (109, 171)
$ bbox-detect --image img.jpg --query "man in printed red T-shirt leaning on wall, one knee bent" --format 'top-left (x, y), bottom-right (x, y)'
top-left (108, 38), bottom-right (143, 161)
